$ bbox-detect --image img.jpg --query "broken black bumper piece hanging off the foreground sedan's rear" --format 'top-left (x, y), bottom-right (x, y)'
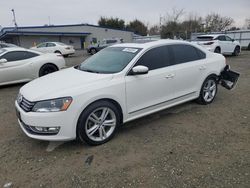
top-left (219, 65), bottom-right (240, 90)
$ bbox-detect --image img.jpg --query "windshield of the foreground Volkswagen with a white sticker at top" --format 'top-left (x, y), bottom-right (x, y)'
top-left (78, 47), bottom-right (141, 74)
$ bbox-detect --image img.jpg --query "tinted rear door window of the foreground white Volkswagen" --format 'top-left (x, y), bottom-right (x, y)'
top-left (171, 44), bottom-right (206, 64)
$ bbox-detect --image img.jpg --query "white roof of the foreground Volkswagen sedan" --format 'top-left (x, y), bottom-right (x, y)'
top-left (112, 39), bottom-right (196, 49)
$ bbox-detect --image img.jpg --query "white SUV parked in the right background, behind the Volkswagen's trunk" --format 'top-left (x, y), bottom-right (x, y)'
top-left (194, 34), bottom-right (241, 56)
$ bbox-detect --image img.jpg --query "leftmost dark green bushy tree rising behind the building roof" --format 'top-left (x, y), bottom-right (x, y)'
top-left (98, 16), bottom-right (125, 29)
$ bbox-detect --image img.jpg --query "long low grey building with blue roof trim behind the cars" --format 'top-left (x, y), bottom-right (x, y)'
top-left (0, 24), bottom-right (133, 49)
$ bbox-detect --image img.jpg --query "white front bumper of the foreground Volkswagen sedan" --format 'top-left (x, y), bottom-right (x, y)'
top-left (15, 102), bottom-right (76, 141)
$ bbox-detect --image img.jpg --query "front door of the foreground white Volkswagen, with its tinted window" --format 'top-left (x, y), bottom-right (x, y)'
top-left (125, 46), bottom-right (175, 115)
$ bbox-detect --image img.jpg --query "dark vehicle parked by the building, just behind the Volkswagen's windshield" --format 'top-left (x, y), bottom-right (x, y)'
top-left (87, 38), bottom-right (123, 55)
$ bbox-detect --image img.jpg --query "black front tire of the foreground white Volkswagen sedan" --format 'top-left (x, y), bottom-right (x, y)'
top-left (76, 100), bottom-right (121, 146)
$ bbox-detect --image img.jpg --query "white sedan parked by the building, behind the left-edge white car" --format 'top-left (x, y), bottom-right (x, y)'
top-left (31, 42), bottom-right (75, 57)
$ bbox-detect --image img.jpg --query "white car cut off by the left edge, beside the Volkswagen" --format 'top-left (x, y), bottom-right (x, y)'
top-left (0, 47), bottom-right (66, 86)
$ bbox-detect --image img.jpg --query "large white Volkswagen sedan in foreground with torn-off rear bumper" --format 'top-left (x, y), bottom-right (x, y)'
top-left (15, 40), bottom-right (239, 145)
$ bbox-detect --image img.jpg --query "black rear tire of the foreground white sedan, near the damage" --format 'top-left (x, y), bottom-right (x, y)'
top-left (196, 75), bottom-right (218, 105)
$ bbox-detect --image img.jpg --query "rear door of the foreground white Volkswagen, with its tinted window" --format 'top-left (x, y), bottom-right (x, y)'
top-left (170, 44), bottom-right (207, 100)
